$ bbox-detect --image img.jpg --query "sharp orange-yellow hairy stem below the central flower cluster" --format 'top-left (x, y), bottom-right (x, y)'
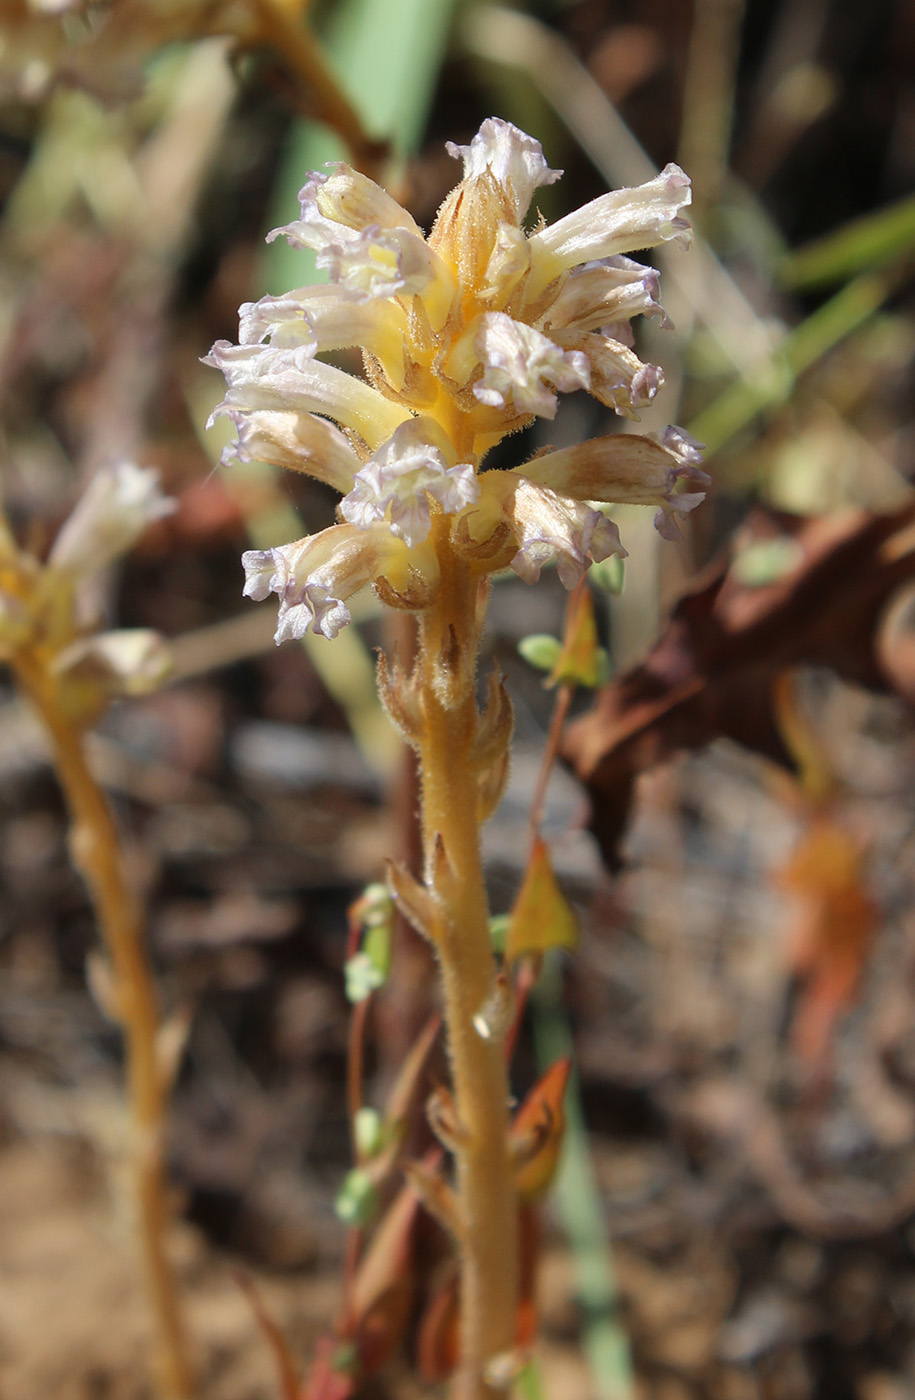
top-left (417, 518), bottom-right (518, 1400)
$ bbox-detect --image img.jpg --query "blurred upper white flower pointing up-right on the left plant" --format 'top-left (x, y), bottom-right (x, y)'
top-left (48, 462), bottom-right (178, 574)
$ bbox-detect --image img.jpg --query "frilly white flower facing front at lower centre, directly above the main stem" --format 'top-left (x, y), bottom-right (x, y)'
top-left (340, 419), bottom-right (480, 547)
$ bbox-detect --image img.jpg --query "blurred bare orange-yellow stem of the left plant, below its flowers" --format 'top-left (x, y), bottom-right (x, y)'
top-left (14, 655), bottom-right (194, 1400)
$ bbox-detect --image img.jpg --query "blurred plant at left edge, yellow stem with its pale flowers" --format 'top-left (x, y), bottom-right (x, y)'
top-left (0, 462), bottom-right (193, 1400)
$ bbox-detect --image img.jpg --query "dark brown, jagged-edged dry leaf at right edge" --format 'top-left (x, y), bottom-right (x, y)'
top-left (560, 503), bottom-right (915, 868)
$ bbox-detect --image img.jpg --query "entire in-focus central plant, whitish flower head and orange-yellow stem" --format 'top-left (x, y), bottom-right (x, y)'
top-left (207, 118), bottom-right (708, 1400)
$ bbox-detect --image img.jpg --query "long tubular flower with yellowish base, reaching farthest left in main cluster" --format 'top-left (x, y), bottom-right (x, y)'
top-left (203, 340), bottom-right (410, 448)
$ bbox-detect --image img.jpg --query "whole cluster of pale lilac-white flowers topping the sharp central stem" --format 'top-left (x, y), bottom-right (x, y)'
top-left (206, 118), bottom-right (708, 641)
